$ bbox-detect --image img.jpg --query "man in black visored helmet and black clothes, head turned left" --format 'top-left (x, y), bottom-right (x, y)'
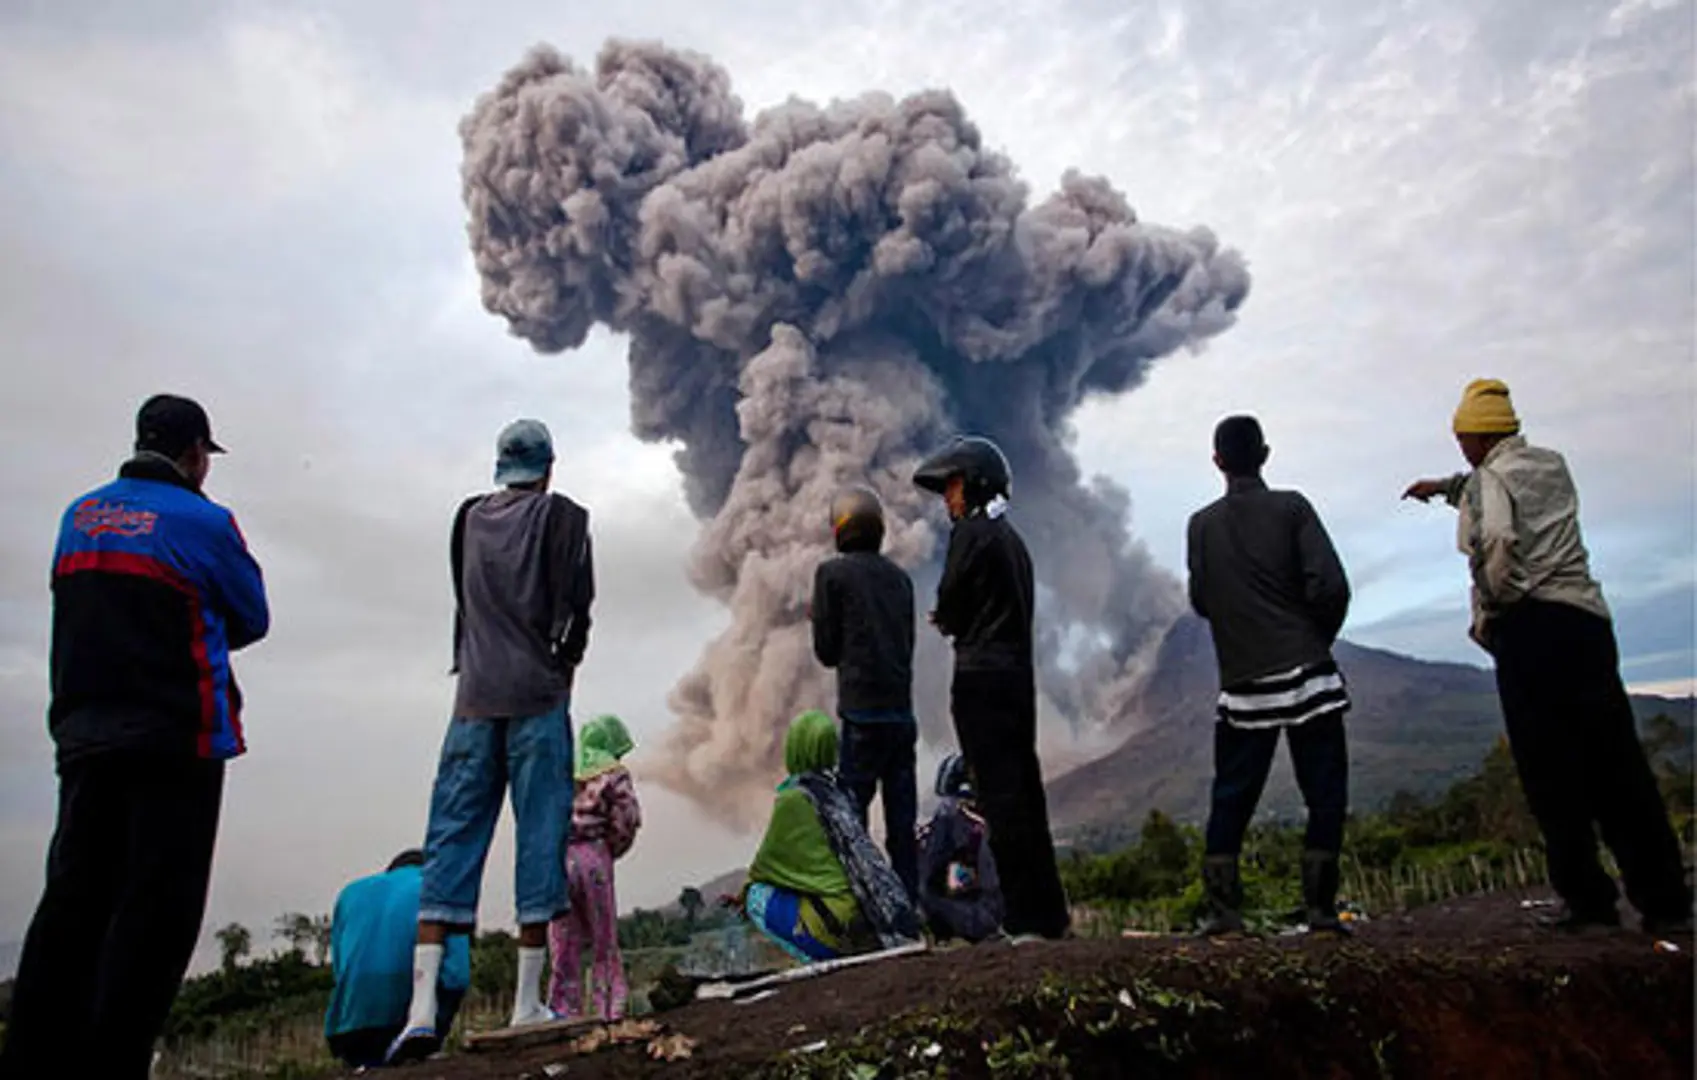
top-left (913, 436), bottom-right (1071, 941)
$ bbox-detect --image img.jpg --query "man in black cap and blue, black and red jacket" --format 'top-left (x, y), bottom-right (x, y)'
top-left (0, 394), bottom-right (270, 1078)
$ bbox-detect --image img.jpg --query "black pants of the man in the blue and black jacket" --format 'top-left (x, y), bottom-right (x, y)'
top-left (0, 752), bottom-right (224, 1080)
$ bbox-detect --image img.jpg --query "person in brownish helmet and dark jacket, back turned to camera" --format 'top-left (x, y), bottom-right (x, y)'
top-left (811, 487), bottom-right (920, 900)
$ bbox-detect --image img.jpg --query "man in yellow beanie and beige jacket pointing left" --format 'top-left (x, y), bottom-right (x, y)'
top-left (1403, 379), bottom-right (1692, 934)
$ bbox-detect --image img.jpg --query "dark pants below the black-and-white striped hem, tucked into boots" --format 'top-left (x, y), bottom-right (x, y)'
top-left (1208, 713), bottom-right (1349, 856)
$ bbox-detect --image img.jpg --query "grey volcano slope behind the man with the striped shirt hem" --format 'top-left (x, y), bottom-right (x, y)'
top-left (1049, 616), bottom-right (1694, 846)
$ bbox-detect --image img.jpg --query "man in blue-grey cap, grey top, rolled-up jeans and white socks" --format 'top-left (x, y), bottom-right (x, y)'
top-left (389, 419), bottom-right (596, 1063)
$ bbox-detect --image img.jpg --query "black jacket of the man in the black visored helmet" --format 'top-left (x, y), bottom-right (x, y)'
top-left (937, 511), bottom-right (1037, 671)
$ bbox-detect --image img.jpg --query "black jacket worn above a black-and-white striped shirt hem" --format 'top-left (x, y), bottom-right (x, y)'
top-left (1186, 477), bottom-right (1349, 688)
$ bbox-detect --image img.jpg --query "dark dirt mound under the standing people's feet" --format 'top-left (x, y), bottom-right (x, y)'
top-left (378, 897), bottom-right (1694, 1080)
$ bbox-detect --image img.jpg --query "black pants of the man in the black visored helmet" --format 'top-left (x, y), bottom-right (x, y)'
top-left (949, 671), bottom-right (1071, 937)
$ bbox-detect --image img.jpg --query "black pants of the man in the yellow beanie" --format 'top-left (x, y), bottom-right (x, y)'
top-left (1490, 599), bottom-right (1690, 919)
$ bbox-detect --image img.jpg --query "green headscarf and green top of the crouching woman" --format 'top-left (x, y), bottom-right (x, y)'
top-left (748, 712), bottom-right (857, 924)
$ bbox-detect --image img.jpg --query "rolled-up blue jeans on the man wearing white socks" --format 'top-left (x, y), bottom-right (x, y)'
top-left (419, 701), bottom-right (572, 927)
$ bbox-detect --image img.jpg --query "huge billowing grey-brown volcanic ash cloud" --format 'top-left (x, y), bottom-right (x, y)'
top-left (460, 41), bottom-right (1249, 825)
